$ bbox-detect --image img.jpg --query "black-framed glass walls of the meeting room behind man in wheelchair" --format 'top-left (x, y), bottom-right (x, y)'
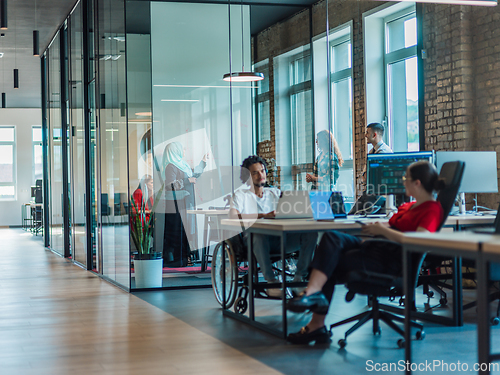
top-left (42, 0), bottom-right (348, 289)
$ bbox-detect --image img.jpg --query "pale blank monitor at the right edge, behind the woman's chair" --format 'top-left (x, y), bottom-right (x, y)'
top-left (436, 151), bottom-right (498, 193)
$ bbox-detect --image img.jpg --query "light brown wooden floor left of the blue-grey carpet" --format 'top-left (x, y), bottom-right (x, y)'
top-left (0, 229), bottom-right (279, 375)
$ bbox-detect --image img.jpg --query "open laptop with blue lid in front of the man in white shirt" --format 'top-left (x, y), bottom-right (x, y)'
top-left (309, 190), bottom-right (347, 220)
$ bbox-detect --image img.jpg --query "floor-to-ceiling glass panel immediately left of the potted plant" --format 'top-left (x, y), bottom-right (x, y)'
top-left (97, 0), bottom-right (130, 288)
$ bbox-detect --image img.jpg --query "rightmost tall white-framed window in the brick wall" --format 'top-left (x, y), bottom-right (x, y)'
top-left (384, 12), bottom-right (419, 151)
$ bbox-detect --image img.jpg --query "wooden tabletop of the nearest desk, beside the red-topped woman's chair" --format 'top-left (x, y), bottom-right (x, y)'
top-left (403, 232), bottom-right (492, 251)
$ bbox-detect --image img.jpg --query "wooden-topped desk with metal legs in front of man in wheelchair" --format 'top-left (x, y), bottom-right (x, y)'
top-left (221, 219), bottom-right (383, 338)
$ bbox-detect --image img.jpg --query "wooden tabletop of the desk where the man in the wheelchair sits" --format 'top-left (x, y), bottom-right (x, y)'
top-left (221, 218), bottom-right (387, 231)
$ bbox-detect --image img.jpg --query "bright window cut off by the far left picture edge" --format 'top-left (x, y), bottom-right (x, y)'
top-left (0, 126), bottom-right (16, 200)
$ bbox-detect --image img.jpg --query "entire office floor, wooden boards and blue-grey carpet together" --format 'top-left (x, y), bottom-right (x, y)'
top-left (0, 229), bottom-right (500, 375)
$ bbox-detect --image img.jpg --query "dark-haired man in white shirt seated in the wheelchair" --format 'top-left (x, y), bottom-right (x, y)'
top-left (229, 155), bottom-right (317, 297)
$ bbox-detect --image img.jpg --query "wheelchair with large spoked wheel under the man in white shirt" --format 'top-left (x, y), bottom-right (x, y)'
top-left (211, 234), bottom-right (298, 314)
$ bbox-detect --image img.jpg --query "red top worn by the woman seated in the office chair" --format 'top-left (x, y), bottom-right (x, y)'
top-left (389, 201), bottom-right (444, 232)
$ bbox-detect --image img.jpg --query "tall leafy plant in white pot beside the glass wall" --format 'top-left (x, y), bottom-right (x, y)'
top-left (130, 186), bottom-right (163, 288)
